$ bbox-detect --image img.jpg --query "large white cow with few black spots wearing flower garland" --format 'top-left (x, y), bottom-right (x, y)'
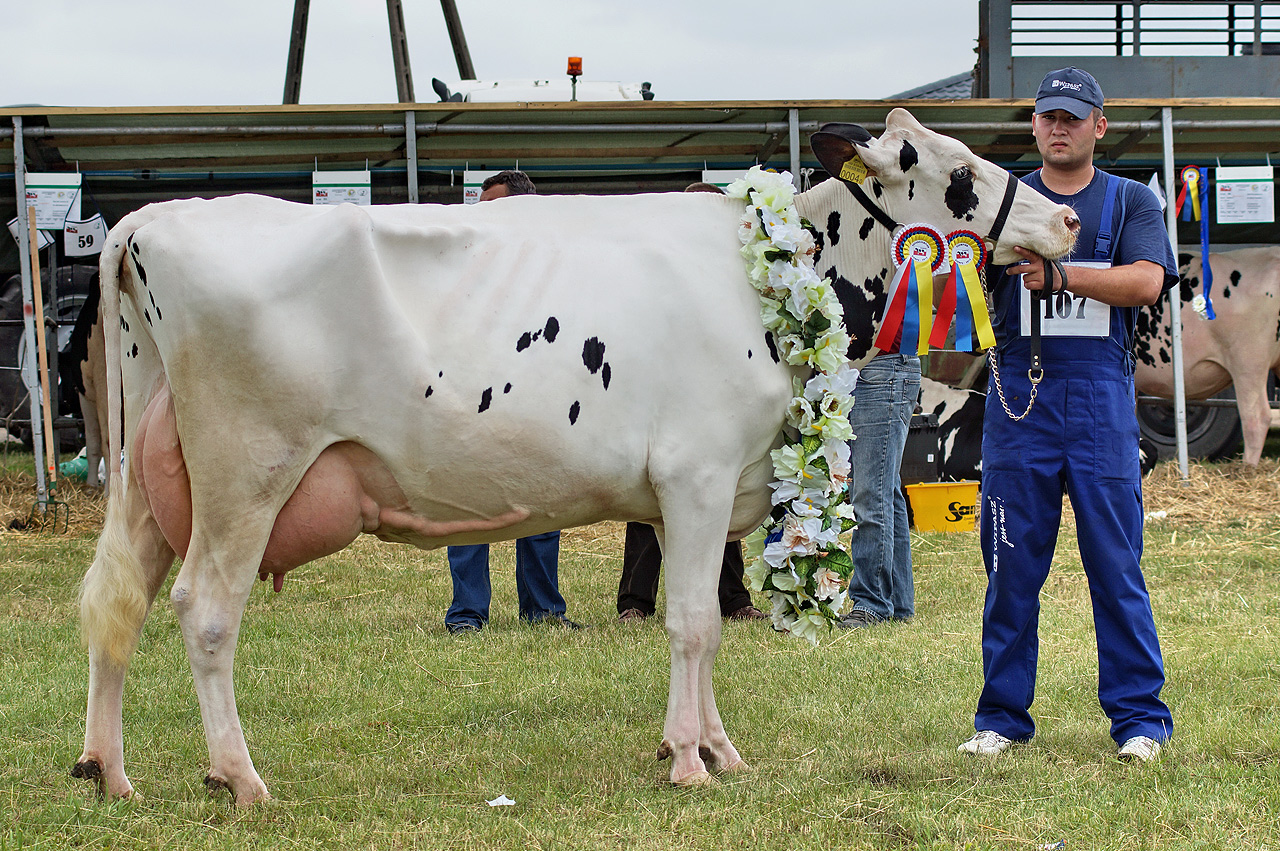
top-left (73, 110), bottom-right (1075, 804)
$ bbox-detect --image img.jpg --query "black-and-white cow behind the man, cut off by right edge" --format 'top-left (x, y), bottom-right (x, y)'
top-left (1134, 246), bottom-right (1280, 465)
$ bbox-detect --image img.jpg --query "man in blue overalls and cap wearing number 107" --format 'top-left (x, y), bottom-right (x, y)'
top-left (960, 68), bottom-right (1178, 761)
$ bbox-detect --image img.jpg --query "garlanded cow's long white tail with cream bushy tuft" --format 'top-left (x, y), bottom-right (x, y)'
top-left (81, 212), bottom-right (150, 665)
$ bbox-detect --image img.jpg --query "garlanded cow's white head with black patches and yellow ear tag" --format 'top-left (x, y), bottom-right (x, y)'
top-left (810, 109), bottom-right (1079, 264)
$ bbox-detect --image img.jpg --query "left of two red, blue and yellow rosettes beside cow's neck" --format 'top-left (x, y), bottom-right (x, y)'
top-left (876, 224), bottom-right (947, 354)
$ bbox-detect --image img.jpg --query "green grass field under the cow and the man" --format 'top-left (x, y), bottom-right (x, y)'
top-left (0, 452), bottom-right (1280, 851)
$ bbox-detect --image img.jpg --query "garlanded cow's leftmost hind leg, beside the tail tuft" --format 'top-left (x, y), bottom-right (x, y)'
top-left (72, 482), bottom-right (174, 797)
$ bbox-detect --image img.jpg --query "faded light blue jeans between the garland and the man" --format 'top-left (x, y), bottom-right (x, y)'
top-left (849, 354), bottom-right (920, 621)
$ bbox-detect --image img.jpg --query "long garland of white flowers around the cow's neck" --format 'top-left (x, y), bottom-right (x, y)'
top-left (726, 166), bottom-right (858, 644)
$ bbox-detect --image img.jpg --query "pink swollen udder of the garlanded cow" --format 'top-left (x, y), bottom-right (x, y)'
top-left (133, 385), bottom-right (529, 590)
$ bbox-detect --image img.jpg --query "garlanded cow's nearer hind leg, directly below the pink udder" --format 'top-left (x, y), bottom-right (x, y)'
top-left (170, 527), bottom-right (271, 806)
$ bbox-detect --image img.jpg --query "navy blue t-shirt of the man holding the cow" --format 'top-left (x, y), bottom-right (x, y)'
top-left (989, 169), bottom-right (1178, 358)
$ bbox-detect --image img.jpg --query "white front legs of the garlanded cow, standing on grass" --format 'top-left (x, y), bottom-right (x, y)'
top-left (659, 482), bottom-right (742, 786)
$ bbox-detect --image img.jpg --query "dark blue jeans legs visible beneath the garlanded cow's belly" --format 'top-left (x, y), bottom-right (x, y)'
top-left (444, 532), bottom-right (564, 627)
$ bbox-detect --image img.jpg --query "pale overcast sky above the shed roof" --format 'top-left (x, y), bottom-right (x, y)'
top-left (0, 0), bottom-right (978, 106)
